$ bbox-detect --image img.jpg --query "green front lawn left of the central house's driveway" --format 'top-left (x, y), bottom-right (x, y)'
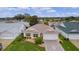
top-left (4, 35), bottom-right (45, 51)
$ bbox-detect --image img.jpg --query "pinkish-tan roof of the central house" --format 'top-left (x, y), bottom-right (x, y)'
top-left (26, 24), bottom-right (54, 33)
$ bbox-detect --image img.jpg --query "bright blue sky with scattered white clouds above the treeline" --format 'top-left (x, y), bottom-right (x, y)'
top-left (0, 7), bottom-right (79, 17)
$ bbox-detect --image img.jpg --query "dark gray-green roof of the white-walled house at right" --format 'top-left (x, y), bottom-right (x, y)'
top-left (57, 22), bottom-right (79, 34)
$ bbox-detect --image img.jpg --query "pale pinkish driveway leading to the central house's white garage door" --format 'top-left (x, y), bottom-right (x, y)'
top-left (44, 40), bottom-right (64, 51)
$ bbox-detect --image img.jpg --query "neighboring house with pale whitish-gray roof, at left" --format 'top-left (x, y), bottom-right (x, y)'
top-left (0, 22), bottom-right (26, 39)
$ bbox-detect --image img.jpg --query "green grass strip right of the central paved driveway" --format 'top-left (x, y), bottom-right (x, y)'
top-left (59, 34), bottom-right (79, 51)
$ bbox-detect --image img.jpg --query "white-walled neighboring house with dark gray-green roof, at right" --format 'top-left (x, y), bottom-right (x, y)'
top-left (55, 22), bottom-right (79, 40)
